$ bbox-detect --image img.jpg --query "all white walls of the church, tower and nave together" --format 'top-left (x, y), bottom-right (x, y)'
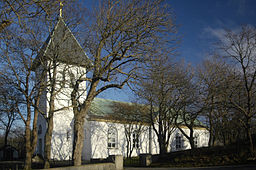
top-left (34, 59), bottom-right (209, 160)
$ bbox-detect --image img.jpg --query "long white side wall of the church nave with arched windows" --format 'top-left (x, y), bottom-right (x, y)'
top-left (82, 120), bottom-right (209, 160)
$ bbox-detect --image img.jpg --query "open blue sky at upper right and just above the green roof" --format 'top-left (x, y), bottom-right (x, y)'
top-left (96, 0), bottom-right (256, 101)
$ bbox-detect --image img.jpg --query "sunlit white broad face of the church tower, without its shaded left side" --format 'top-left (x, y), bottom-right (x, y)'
top-left (48, 64), bottom-right (86, 160)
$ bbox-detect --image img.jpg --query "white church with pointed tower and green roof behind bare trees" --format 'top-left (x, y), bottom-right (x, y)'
top-left (34, 17), bottom-right (209, 160)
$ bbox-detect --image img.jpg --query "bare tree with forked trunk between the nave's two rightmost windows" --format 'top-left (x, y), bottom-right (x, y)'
top-left (173, 65), bottom-right (205, 149)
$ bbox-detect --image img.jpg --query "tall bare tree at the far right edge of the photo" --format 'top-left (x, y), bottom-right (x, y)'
top-left (217, 26), bottom-right (256, 156)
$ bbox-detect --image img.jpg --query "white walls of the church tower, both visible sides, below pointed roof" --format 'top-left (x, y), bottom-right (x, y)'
top-left (36, 63), bottom-right (86, 160)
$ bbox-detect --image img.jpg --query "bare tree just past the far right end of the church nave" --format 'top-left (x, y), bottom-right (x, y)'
top-left (197, 57), bottom-right (229, 146)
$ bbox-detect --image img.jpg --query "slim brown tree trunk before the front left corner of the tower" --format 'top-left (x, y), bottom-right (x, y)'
top-left (44, 116), bottom-right (53, 169)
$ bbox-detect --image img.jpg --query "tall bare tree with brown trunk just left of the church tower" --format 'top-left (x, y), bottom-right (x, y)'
top-left (1, 24), bottom-right (43, 169)
